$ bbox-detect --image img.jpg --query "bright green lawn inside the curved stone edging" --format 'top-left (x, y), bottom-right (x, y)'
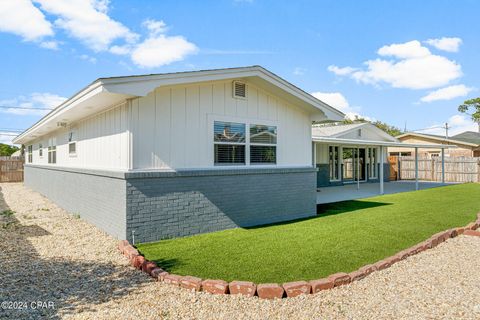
top-left (138, 183), bottom-right (480, 283)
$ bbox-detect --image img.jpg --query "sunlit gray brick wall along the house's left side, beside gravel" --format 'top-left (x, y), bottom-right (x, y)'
top-left (25, 165), bottom-right (126, 239)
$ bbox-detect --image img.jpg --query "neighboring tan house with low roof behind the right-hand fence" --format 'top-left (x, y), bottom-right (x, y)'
top-left (388, 131), bottom-right (480, 158)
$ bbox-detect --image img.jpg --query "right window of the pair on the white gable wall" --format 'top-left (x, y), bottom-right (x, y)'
top-left (250, 124), bottom-right (277, 164)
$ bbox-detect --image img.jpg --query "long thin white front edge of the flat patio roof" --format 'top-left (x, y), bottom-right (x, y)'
top-left (312, 136), bottom-right (457, 149)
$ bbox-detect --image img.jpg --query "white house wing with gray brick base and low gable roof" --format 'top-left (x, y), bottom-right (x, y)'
top-left (14, 66), bottom-right (344, 242)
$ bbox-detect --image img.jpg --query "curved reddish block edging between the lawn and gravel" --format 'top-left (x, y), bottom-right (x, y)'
top-left (118, 213), bottom-right (480, 299)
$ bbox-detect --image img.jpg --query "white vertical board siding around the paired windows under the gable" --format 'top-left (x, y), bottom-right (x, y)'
top-left (129, 81), bottom-right (311, 169)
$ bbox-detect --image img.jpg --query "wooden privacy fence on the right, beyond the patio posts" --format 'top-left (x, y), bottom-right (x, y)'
top-left (398, 157), bottom-right (480, 182)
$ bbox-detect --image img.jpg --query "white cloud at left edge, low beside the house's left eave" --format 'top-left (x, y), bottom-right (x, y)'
top-left (0, 92), bottom-right (67, 116)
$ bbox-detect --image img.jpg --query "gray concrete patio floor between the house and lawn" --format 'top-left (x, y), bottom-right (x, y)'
top-left (317, 180), bottom-right (452, 204)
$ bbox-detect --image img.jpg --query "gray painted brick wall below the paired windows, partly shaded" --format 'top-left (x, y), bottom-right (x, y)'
top-left (127, 168), bottom-right (316, 242)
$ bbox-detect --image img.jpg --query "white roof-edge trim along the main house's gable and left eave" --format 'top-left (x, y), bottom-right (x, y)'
top-left (12, 65), bottom-right (345, 143)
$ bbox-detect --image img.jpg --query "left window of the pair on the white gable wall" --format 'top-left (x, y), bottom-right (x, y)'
top-left (213, 121), bottom-right (246, 165)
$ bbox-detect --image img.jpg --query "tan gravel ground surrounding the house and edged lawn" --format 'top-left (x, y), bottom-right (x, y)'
top-left (0, 184), bottom-right (480, 319)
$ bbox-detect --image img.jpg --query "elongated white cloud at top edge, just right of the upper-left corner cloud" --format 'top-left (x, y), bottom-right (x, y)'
top-left (34, 0), bottom-right (138, 51)
